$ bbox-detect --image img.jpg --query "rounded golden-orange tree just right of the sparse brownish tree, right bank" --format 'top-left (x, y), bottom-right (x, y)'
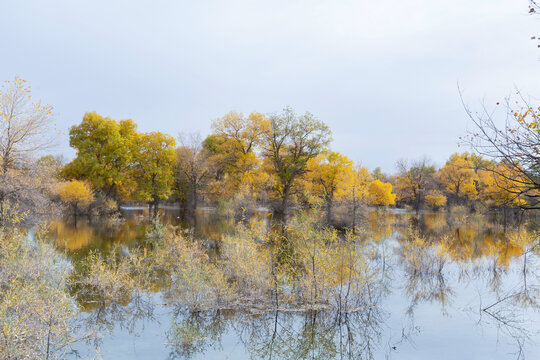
top-left (436, 152), bottom-right (478, 201)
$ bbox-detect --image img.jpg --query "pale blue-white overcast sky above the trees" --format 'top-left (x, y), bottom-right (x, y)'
top-left (0, 0), bottom-right (540, 173)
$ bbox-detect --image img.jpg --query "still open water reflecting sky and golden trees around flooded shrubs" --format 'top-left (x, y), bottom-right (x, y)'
top-left (49, 209), bottom-right (540, 360)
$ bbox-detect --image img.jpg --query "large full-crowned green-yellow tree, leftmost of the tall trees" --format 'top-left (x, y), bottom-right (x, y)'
top-left (61, 112), bottom-right (138, 200)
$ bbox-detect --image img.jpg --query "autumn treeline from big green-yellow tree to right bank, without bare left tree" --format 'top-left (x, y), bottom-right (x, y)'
top-left (60, 108), bottom-right (524, 223)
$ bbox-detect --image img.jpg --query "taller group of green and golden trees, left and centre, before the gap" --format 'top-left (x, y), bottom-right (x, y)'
top-left (60, 108), bottom-right (395, 221)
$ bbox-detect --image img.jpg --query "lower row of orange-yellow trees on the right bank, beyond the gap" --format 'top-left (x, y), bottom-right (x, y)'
top-left (389, 152), bottom-right (527, 211)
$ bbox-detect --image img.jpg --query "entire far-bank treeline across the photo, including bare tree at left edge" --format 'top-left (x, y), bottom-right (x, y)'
top-left (0, 78), bottom-right (538, 225)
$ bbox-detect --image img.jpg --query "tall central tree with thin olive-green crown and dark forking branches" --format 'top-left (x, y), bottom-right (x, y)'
top-left (264, 107), bottom-right (331, 221)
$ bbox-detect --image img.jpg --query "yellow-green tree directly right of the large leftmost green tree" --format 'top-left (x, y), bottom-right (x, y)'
top-left (133, 132), bottom-right (176, 214)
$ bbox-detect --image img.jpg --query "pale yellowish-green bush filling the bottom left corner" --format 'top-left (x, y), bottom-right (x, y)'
top-left (0, 227), bottom-right (78, 359)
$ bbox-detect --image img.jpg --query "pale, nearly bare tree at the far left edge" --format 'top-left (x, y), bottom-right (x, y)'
top-left (0, 78), bottom-right (54, 225)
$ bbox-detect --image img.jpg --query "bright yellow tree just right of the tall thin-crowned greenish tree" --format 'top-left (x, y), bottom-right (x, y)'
top-left (307, 151), bottom-right (352, 223)
